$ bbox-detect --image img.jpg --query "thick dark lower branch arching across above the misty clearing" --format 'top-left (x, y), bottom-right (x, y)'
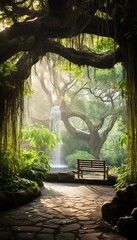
top-left (0, 38), bottom-right (123, 74)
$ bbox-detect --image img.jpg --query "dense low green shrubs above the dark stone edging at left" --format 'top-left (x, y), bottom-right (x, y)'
top-left (0, 145), bottom-right (50, 185)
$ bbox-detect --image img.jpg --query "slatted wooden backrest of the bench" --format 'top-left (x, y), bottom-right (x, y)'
top-left (77, 159), bottom-right (106, 169)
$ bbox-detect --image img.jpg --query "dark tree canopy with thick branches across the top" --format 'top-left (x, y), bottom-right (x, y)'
top-left (0, 0), bottom-right (125, 68)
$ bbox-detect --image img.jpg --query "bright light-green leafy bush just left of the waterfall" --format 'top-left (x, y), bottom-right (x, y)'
top-left (22, 124), bottom-right (60, 150)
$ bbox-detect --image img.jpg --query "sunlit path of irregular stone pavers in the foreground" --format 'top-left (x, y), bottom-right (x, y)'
top-left (0, 182), bottom-right (125, 240)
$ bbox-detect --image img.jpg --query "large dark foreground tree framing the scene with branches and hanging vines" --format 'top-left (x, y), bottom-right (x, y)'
top-left (0, 0), bottom-right (137, 179)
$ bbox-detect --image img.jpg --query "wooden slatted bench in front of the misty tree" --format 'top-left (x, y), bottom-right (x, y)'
top-left (77, 159), bottom-right (108, 179)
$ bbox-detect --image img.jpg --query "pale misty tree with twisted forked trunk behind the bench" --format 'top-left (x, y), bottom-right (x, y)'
top-left (28, 58), bottom-right (124, 159)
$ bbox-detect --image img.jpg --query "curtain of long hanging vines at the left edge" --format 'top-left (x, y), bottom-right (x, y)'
top-left (0, 58), bottom-right (24, 151)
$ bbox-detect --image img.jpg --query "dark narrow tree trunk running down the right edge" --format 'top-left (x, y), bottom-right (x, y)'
top-left (123, 0), bottom-right (137, 182)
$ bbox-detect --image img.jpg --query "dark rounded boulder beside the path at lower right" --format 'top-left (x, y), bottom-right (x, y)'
top-left (101, 184), bottom-right (137, 236)
